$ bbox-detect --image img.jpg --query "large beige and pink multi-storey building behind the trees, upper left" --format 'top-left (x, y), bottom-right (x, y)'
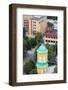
top-left (23, 15), bottom-right (47, 36)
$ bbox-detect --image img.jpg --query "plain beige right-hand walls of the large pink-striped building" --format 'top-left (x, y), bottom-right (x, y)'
top-left (32, 17), bottom-right (47, 33)
